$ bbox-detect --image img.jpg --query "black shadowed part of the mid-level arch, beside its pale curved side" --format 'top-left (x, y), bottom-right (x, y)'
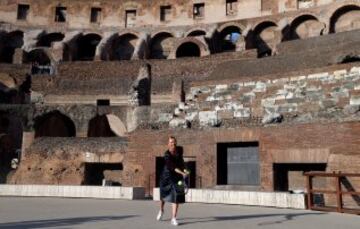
top-left (88, 115), bottom-right (116, 137)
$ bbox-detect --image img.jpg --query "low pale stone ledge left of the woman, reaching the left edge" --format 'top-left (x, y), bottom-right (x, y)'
top-left (0, 185), bottom-right (145, 200)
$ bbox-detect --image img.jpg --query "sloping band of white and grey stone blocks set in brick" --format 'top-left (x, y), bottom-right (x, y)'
top-left (162, 67), bottom-right (360, 128)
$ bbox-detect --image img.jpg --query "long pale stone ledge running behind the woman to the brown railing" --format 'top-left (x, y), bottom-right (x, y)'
top-left (153, 188), bottom-right (306, 209)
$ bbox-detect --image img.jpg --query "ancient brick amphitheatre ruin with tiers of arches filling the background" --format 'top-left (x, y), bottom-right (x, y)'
top-left (0, 0), bottom-right (360, 210)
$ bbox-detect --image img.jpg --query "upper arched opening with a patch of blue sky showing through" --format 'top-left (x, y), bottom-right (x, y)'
top-left (219, 26), bottom-right (241, 52)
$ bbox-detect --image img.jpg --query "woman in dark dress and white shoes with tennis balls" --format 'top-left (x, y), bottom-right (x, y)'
top-left (156, 136), bottom-right (188, 226)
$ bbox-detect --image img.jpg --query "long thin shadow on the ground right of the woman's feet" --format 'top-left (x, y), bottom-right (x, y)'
top-left (181, 212), bottom-right (326, 226)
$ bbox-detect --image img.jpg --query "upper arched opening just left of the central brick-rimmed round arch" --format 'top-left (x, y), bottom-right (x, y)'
top-left (150, 32), bottom-right (173, 59)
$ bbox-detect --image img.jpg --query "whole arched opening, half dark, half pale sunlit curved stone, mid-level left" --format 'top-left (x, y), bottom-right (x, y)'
top-left (88, 114), bottom-right (127, 137)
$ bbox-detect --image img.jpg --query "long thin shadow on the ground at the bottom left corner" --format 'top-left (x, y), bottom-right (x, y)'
top-left (0, 215), bottom-right (138, 229)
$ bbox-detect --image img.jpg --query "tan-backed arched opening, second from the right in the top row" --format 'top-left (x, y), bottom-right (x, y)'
top-left (283, 15), bottom-right (324, 40)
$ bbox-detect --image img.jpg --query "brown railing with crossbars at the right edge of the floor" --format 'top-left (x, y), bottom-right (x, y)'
top-left (304, 172), bottom-right (360, 215)
